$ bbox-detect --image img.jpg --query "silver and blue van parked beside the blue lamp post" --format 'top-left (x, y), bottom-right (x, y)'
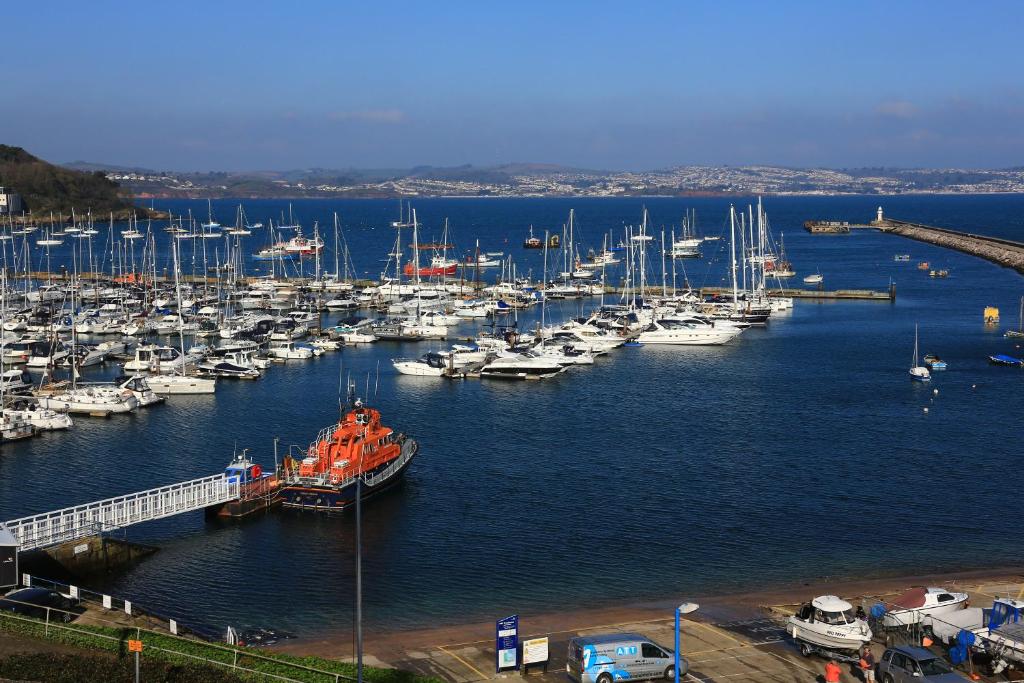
top-left (565, 633), bottom-right (689, 683)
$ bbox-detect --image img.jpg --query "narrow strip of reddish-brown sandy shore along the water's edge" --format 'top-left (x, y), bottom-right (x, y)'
top-left (274, 567), bottom-right (1024, 661)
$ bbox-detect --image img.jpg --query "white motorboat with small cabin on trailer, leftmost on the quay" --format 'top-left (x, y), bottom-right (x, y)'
top-left (785, 595), bottom-right (871, 652)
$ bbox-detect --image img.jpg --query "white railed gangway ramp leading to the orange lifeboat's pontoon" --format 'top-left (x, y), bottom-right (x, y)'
top-left (3, 473), bottom-right (241, 551)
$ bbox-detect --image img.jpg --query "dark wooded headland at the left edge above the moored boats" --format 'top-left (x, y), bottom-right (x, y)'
top-left (0, 144), bottom-right (142, 217)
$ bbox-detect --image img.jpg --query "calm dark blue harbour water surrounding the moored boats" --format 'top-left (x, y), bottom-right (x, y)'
top-left (0, 196), bottom-right (1024, 635)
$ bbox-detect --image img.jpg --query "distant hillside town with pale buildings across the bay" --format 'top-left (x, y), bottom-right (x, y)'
top-left (65, 162), bottom-right (1024, 198)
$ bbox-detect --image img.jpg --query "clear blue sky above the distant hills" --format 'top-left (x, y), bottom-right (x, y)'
top-left (0, 0), bottom-right (1024, 170)
